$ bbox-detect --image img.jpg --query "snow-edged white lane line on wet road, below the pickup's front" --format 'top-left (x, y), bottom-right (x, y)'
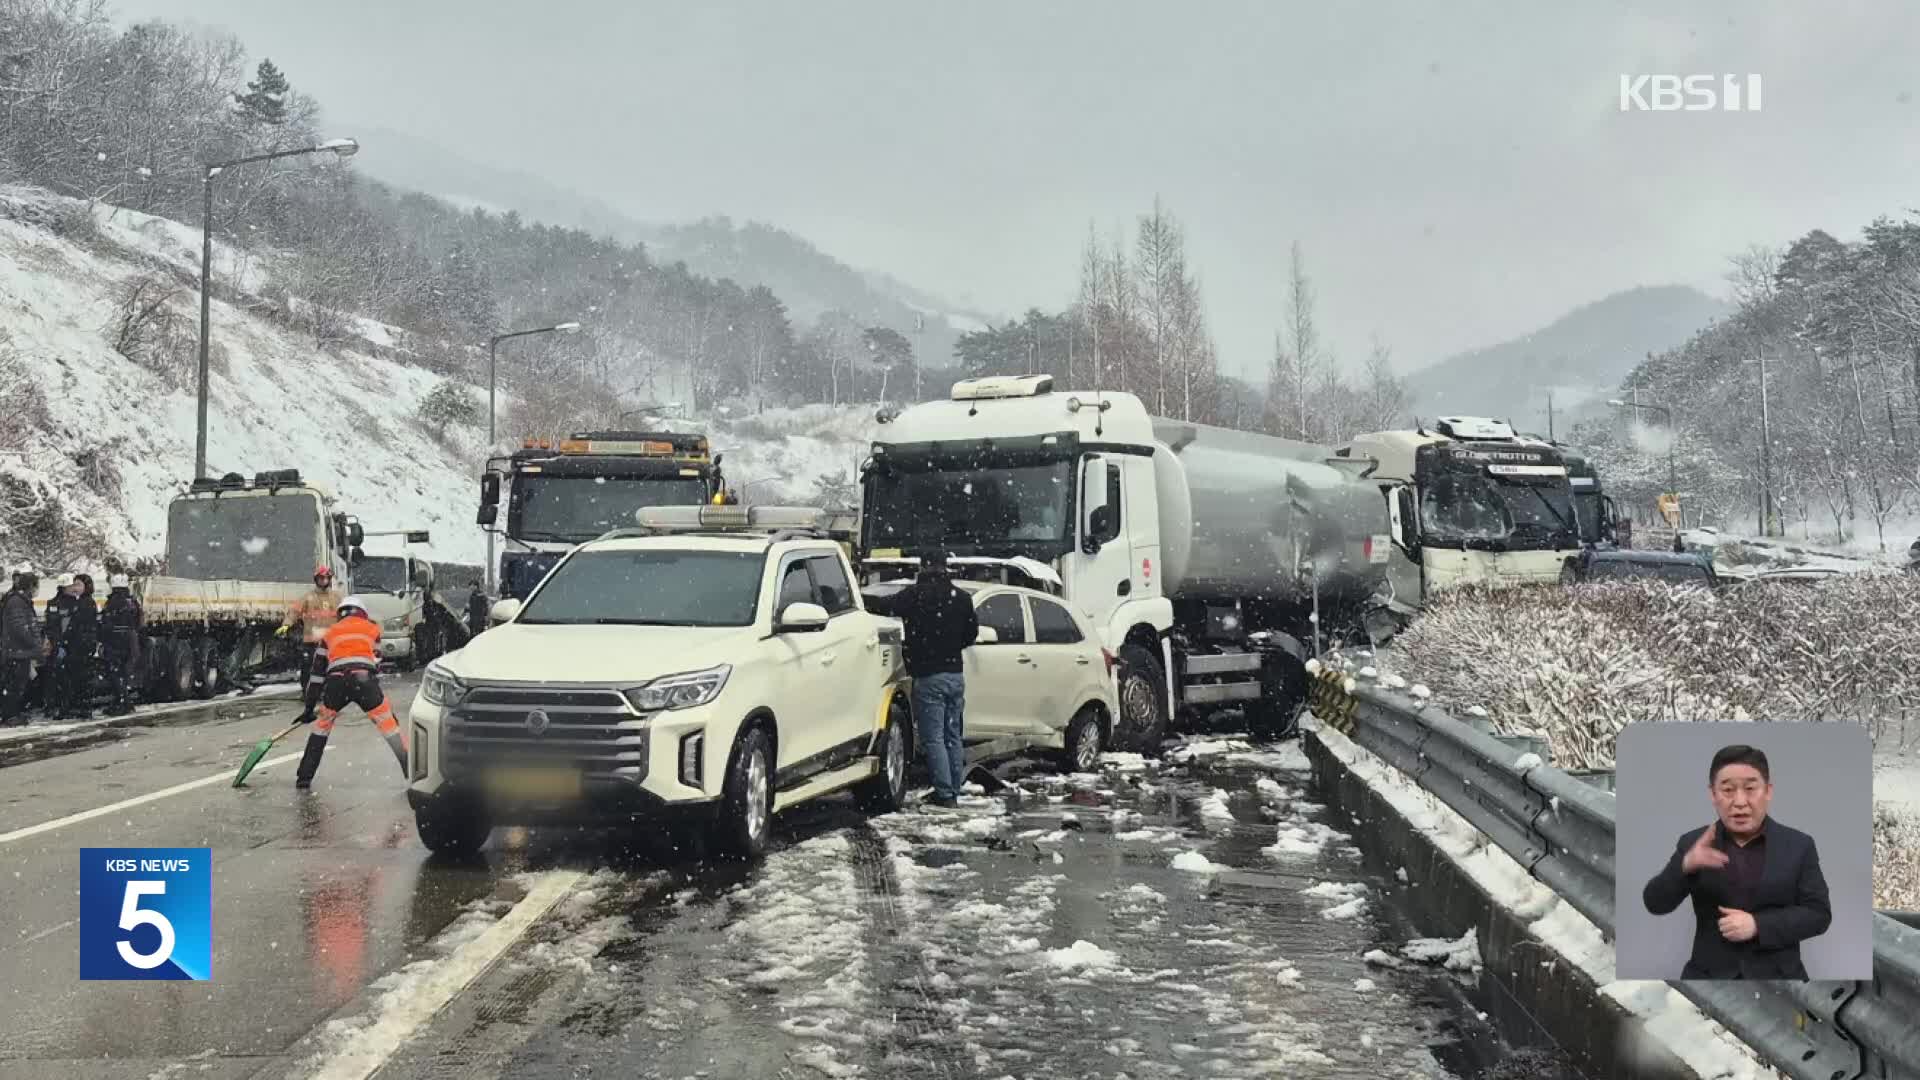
top-left (303, 871), bottom-right (586, 1080)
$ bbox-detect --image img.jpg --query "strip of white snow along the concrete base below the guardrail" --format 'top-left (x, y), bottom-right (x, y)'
top-left (1306, 719), bottom-right (1774, 1080)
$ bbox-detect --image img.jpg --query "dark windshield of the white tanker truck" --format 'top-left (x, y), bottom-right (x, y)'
top-left (862, 461), bottom-right (1071, 548)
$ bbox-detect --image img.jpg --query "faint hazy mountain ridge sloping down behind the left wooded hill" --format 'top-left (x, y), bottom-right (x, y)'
top-left (355, 127), bottom-right (991, 365)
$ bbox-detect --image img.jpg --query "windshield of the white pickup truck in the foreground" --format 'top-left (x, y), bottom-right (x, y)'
top-left (518, 552), bottom-right (766, 626)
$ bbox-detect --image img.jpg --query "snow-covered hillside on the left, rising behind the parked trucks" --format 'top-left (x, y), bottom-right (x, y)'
top-left (0, 188), bottom-right (874, 569)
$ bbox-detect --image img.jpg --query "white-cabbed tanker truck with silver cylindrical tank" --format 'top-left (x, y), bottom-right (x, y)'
top-left (858, 375), bottom-right (1392, 748)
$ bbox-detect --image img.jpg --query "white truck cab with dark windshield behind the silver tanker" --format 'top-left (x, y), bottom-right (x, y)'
top-left (1336, 417), bottom-right (1582, 595)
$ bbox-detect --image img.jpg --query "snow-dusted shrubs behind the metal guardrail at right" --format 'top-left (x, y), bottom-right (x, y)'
top-left (1382, 575), bottom-right (1920, 769)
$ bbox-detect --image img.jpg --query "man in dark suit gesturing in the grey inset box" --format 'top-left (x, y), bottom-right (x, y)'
top-left (1642, 746), bottom-right (1834, 980)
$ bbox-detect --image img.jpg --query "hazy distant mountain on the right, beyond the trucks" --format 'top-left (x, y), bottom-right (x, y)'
top-left (1407, 284), bottom-right (1730, 432)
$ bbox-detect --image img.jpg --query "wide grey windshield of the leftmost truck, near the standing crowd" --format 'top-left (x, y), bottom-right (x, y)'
top-left (167, 492), bottom-right (323, 582)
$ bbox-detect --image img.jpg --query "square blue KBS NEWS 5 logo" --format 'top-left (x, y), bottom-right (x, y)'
top-left (81, 847), bottom-right (213, 980)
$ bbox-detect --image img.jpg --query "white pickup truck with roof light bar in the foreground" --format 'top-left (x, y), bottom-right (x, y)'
top-left (407, 505), bottom-right (912, 857)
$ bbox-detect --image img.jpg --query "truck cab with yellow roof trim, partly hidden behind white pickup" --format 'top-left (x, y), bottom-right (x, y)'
top-left (470, 430), bottom-right (732, 618)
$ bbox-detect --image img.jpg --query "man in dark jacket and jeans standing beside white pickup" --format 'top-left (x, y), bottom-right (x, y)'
top-left (868, 552), bottom-right (979, 807)
